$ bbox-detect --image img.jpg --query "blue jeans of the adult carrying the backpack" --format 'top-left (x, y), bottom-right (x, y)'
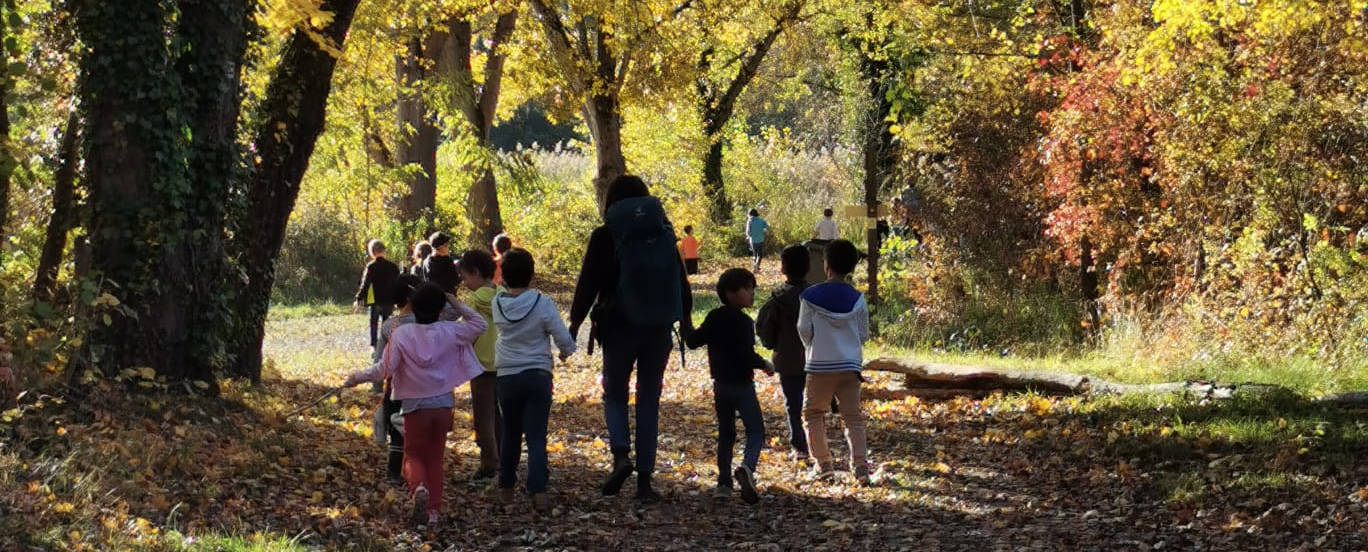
top-left (601, 325), bottom-right (674, 480)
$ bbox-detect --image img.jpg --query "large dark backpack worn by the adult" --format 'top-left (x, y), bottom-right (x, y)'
top-left (603, 195), bottom-right (684, 327)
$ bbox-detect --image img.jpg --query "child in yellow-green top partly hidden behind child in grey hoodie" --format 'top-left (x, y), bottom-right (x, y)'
top-left (456, 249), bottom-right (502, 480)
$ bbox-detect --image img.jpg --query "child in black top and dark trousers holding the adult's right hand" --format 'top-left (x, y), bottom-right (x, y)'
top-left (684, 268), bottom-right (774, 504)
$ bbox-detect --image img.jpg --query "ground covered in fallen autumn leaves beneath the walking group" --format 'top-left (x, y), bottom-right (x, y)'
top-left (0, 306), bottom-right (1368, 551)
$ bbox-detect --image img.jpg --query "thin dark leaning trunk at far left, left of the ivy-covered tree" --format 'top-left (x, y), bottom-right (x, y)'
top-left (33, 111), bottom-right (81, 302)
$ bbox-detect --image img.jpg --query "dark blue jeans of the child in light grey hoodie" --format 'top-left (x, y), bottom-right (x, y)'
top-left (498, 370), bottom-right (551, 495)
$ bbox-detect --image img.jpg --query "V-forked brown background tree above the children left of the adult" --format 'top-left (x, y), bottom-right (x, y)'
top-left (439, 4), bottom-right (518, 243)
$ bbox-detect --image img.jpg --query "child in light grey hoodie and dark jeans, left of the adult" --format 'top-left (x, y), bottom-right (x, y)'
top-left (492, 247), bottom-right (576, 512)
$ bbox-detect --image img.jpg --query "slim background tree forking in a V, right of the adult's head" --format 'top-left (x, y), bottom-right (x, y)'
top-left (695, 0), bottom-right (803, 224)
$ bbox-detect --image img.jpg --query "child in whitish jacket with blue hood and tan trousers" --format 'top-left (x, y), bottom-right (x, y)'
top-left (798, 239), bottom-right (869, 485)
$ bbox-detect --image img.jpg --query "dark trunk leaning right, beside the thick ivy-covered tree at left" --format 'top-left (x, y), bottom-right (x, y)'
top-left (231, 0), bottom-right (360, 381)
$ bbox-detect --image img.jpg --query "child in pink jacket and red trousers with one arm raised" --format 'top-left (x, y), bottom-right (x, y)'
top-left (343, 283), bottom-right (487, 526)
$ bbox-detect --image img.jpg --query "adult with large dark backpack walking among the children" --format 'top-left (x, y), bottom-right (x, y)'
top-left (569, 175), bottom-right (694, 503)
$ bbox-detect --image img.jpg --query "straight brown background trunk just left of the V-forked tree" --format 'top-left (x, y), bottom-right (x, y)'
top-left (394, 36), bottom-right (438, 227)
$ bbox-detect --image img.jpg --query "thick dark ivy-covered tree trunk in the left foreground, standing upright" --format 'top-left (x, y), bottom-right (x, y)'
top-left (73, 0), bottom-right (248, 381)
